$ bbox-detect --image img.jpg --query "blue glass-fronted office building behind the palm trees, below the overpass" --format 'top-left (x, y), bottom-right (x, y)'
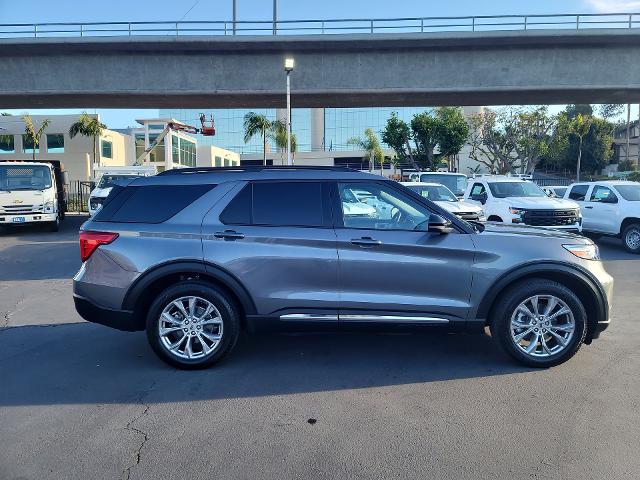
top-left (160, 107), bottom-right (430, 154)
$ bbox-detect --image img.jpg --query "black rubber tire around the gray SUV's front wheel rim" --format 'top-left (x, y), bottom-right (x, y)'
top-left (490, 278), bottom-right (587, 368)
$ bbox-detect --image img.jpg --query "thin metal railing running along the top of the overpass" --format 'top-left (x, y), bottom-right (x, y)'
top-left (0, 13), bottom-right (640, 38)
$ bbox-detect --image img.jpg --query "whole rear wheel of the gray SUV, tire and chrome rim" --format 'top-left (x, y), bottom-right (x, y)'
top-left (146, 280), bottom-right (240, 369)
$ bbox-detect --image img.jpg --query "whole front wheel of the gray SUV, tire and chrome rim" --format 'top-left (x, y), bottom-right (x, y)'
top-left (491, 279), bottom-right (587, 367)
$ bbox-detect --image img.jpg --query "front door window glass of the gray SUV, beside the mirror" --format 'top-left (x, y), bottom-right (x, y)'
top-left (338, 182), bottom-right (430, 230)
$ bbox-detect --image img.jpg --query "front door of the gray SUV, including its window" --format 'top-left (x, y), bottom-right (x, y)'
top-left (334, 181), bottom-right (475, 324)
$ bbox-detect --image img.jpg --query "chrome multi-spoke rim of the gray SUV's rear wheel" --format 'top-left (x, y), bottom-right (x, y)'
top-left (158, 297), bottom-right (223, 360)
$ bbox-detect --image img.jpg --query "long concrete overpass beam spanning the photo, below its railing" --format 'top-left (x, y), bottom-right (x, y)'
top-left (0, 29), bottom-right (640, 109)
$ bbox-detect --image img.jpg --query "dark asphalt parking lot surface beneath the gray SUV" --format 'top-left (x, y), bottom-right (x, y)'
top-left (0, 217), bottom-right (640, 480)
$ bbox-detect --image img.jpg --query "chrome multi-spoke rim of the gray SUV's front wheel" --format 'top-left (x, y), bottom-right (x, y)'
top-left (511, 295), bottom-right (576, 358)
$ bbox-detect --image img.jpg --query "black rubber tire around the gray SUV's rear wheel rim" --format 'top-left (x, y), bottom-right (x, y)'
top-left (146, 280), bottom-right (240, 370)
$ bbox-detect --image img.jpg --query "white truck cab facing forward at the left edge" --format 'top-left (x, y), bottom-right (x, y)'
top-left (0, 160), bottom-right (68, 231)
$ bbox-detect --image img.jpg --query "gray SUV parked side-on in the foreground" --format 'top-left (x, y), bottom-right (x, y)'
top-left (73, 167), bottom-right (613, 368)
